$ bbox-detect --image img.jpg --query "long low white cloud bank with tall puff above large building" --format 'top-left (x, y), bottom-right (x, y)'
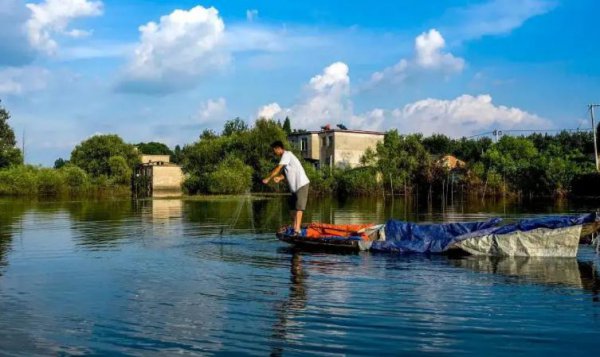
top-left (258, 62), bottom-right (551, 137)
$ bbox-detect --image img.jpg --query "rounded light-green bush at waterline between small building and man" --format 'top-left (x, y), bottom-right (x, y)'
top-left (208, 156), bottom-right (252, 194)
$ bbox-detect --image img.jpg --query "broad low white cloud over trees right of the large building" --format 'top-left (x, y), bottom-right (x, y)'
top-left (386, 94), bottom-right (550, 137)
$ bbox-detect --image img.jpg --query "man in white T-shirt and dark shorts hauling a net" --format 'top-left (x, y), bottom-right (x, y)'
top-left (263, 141), bottom-right (310, 234)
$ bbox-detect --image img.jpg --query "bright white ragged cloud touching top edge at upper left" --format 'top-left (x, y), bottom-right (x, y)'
top-left (25, 0), bottom-right (103, 54)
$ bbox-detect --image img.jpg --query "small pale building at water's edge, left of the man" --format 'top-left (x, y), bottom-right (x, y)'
top-left (132, 154), bottom-right (184, 197)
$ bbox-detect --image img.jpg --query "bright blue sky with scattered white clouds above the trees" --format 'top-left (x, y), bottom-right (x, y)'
top-left (0, 0), bottom-right (600, 166)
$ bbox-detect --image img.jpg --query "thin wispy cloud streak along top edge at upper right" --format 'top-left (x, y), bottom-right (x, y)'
top-left (442, 0), bottom-right (557, 41)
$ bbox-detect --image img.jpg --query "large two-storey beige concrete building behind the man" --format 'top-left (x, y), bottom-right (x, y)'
top-left (288, 129), bottom-right (384, 168)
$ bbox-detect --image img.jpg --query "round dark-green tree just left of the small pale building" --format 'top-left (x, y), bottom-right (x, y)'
top-left (71, 135), bottom-right (140, 177)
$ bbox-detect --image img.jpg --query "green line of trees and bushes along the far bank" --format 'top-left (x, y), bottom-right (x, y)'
top-left (0, 98), bottom-right (600, 199)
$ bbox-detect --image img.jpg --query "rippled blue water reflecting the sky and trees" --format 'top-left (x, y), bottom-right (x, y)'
top-left (0, 197), bottom-right (600, 356)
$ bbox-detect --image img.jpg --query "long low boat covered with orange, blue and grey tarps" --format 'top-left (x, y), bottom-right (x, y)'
top-left (277, 213), bottom-right (600, 257)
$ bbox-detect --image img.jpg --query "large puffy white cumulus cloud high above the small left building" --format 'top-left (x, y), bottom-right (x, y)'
top-left (118, 6), bottom-right (230, 93)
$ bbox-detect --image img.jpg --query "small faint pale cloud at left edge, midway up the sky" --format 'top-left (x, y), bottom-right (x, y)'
top-left (0, 66), bottom-right (50, 95)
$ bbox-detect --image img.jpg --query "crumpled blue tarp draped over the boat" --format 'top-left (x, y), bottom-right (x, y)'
top-left (371, 213), bottom-right (598, 253)
